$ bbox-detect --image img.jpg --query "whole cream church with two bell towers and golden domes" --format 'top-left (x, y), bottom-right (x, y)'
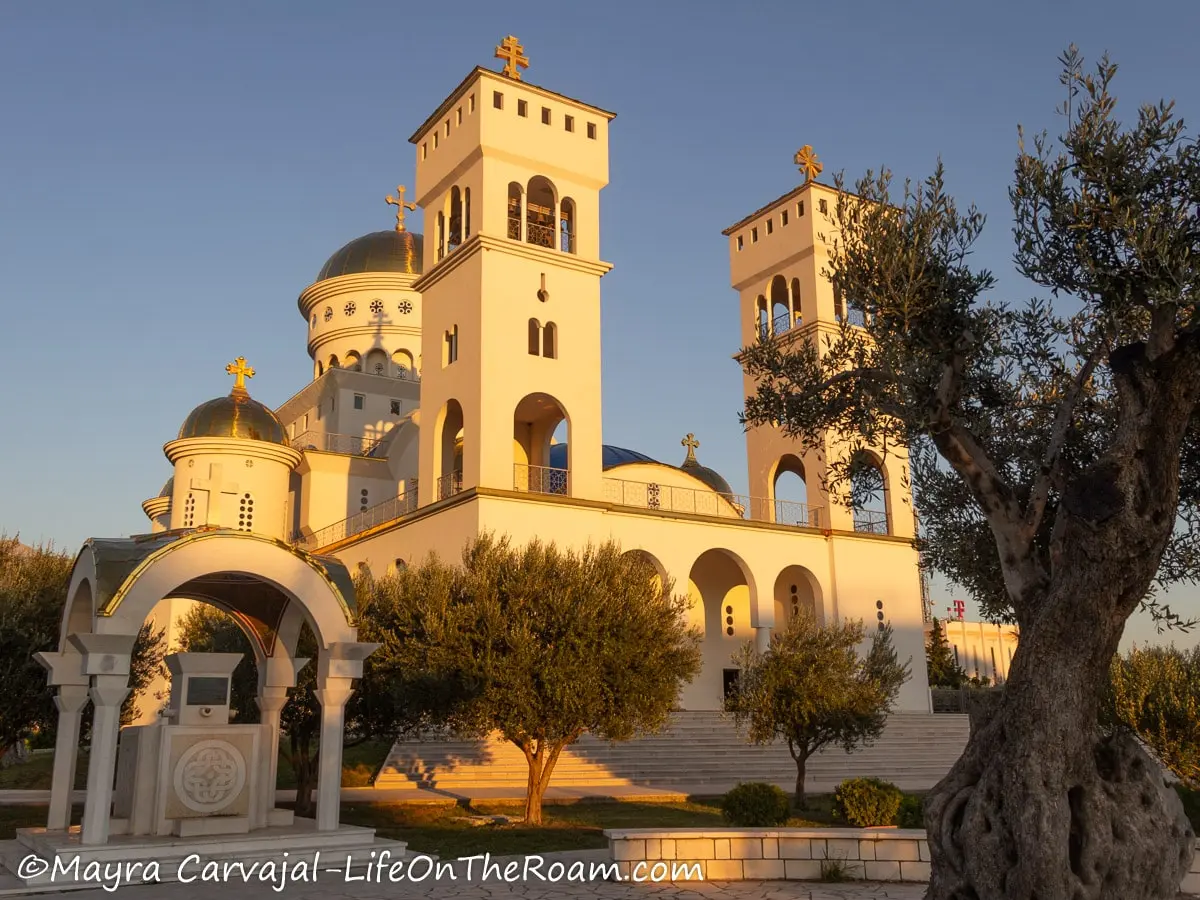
top-left (136, 37), bottom-right (930, 713)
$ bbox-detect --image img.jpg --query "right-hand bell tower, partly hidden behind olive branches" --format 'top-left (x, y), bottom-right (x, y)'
top-left (722, 150), bottom-right (913, 538)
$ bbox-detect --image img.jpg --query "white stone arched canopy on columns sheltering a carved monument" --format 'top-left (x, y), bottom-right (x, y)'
top-left (38, 529), bottom-right (376, 846)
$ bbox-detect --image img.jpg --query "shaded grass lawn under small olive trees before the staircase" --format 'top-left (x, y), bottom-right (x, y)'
top-left (342, 796), bottom-right (834, 858)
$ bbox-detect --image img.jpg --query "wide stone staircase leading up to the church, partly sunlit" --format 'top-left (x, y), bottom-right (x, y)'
top-left (376, 712), bottom-right (968, 794)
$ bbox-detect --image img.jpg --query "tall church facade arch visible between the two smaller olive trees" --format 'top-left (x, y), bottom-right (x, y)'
top-left (683, 548), bottom-right (757, 709)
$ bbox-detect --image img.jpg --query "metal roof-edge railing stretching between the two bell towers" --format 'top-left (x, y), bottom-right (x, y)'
top-left (604, 478), bottom-right (822, 528)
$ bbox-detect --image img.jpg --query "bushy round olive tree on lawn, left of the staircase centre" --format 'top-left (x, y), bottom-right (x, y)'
top-left (372, 535), bottom-right (700, 824)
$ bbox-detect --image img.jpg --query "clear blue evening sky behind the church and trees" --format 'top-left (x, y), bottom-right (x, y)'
top-left (0, 0), bottom-right (1200, 642)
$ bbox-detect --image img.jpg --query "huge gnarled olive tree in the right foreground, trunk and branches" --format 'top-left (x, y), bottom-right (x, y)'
top-left (744, 48), bottom-right (1200, 900)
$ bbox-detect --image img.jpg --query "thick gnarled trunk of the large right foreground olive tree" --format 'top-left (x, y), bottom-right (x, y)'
top-left (926, 403), bottom-right (1194, 900)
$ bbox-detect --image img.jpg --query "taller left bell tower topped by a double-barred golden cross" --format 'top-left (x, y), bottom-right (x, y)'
top-left (410, 36), bottom-right (613, 505)
